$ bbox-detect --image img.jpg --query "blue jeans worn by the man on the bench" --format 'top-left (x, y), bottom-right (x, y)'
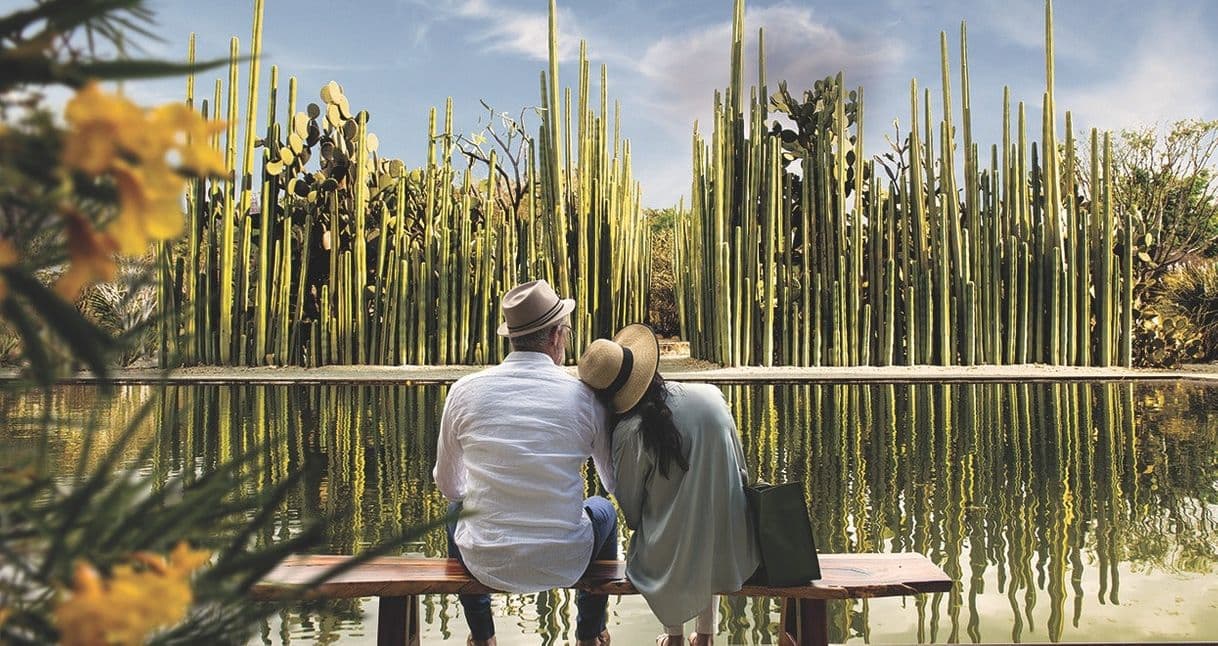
top-left (448, 496), bottom-right (618, 640)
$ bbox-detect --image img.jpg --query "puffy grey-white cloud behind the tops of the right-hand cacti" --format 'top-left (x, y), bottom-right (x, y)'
top-left (636, 4), bottom-right (904, 133)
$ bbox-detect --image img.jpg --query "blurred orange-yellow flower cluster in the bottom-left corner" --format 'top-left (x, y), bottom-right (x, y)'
top-left (55, 542), bottom-right (209, 646)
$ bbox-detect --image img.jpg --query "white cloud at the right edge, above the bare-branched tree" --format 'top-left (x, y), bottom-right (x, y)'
top-left (1057, 15), bottom-right (1218, 128)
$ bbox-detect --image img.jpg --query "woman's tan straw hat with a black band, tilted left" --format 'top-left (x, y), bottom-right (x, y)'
top-left (580, 323), bottom-right (660, 413)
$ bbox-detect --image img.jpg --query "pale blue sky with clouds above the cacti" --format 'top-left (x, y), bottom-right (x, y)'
top-left (118, 0), bottom-right (1218, 206)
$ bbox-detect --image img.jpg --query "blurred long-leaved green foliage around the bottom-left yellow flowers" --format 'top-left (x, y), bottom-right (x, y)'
top-left (0, 401), bottom-right (320, 644)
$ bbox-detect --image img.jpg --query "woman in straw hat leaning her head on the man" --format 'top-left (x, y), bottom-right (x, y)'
top-left (580, 324), bottom-right (759, 646)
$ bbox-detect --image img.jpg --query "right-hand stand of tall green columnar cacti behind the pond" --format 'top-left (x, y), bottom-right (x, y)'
top-left (676, 0), bottom-right (1133, 366)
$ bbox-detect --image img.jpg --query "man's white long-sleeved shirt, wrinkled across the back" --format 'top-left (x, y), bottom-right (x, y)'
top-left (432, 351), bottom-right (614, 592)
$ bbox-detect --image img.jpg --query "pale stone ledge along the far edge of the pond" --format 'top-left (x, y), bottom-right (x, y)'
top-left (0, 358), bottom-right (1218, 384)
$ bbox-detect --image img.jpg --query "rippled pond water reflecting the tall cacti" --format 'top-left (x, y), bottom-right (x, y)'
top-left (0, 383), bottom-right (1218, 646)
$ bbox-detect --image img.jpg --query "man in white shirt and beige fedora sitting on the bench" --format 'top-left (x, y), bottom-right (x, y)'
top-left (432, 280), bottom-right (618, 646)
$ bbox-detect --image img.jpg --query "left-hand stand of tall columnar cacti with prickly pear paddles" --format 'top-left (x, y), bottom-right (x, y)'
top-left (169, 0), bottom-right (649, 366)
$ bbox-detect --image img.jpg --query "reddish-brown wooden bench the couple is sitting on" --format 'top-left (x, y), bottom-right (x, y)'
top-left (253, 553), bottom-right (951, 646)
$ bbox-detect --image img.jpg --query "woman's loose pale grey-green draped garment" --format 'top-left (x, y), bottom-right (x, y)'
top-left (613, 382), bottom-right (760, 625)
